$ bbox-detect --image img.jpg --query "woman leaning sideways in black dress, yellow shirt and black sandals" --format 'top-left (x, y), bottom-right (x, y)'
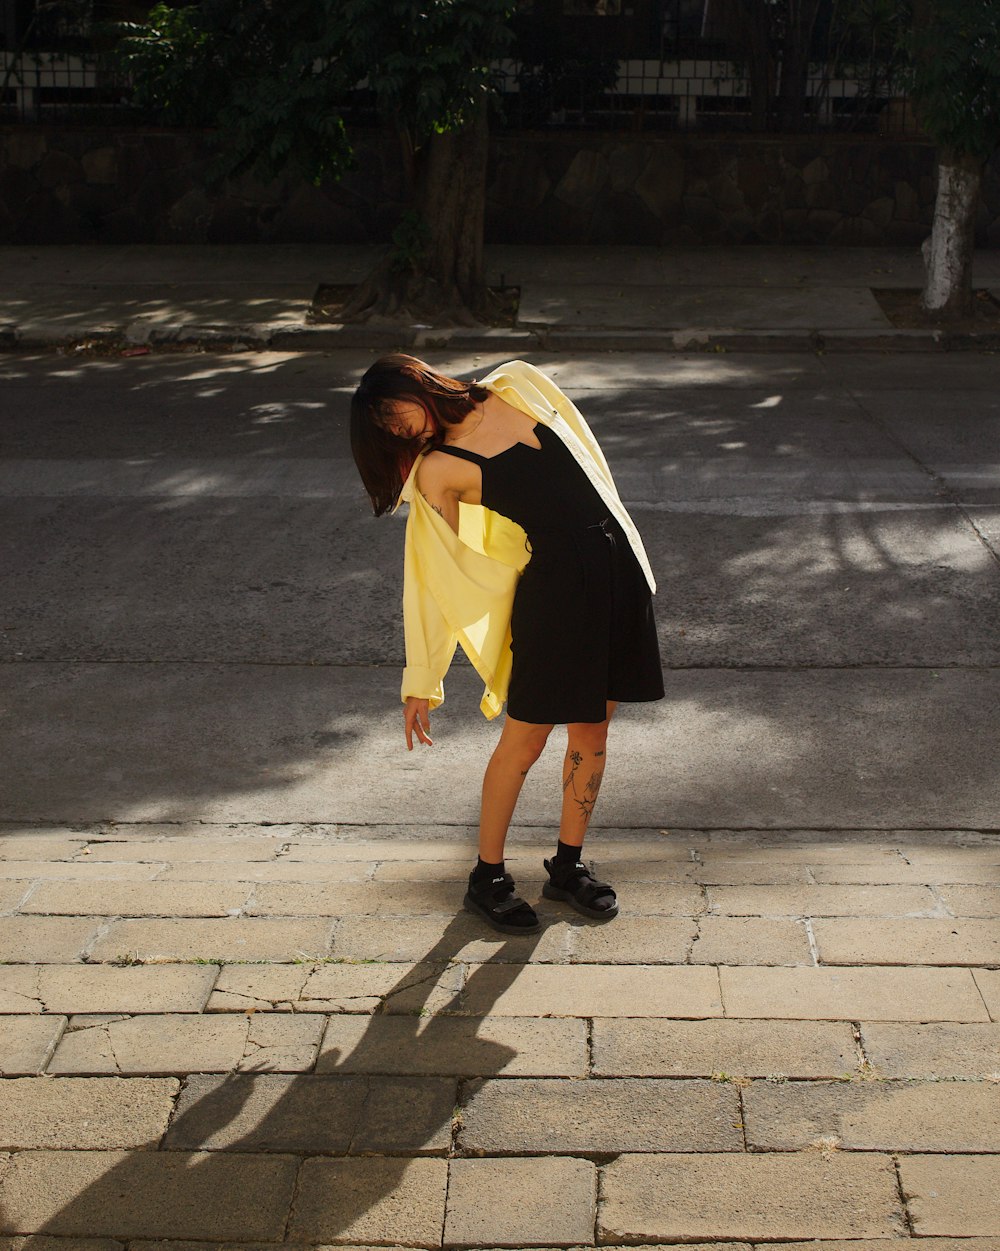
top-left (350, 354), bottom-right (663, 933)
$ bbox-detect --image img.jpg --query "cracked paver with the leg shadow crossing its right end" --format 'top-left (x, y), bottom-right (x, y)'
top-left (208, 963), bottom-right (464, 1016)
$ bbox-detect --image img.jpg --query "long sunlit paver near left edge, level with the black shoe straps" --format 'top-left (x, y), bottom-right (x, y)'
top-left (20, 882), bottom-right (253, 917)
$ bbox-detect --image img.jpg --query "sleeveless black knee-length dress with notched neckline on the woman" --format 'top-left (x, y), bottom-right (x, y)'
top-left (437, 422), bottom-right (663, 724)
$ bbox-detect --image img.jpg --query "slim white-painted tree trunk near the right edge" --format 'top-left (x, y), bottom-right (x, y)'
top-left (921, 149), bottom-right (984, 320)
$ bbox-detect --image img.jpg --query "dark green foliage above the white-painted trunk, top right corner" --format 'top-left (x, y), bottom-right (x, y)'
top-left (910, 0), bottom-right (1000, 161)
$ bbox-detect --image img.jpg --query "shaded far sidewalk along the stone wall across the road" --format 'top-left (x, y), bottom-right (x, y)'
top-left (0, 245), bottom-right (1000, 352)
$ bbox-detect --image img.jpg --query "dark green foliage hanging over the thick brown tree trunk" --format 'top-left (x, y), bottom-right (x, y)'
top-left (119, 0), bottom-right (512, 181)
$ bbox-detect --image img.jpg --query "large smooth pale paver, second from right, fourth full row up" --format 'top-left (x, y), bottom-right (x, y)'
top-left (718, 966), bottom-right (989, 1021)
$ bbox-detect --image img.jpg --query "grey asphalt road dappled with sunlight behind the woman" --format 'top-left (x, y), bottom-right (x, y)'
top-left (0, 353), bottom-right (1000, 834)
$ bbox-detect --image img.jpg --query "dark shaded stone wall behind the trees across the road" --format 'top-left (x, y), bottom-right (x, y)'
top-left (0, 126), bottom-right (1000, 246)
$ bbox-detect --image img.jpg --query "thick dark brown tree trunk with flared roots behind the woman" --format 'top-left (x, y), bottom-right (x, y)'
top-left (342, 106), bottom-right (494, 327)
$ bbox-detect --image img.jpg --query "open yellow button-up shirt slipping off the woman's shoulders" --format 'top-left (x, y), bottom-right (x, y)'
top-left (395, 360), bottom-right (656, 718)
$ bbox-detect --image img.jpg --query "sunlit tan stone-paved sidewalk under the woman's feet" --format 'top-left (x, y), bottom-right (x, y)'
top-left (0, 823), bottom-right (1000, 1251)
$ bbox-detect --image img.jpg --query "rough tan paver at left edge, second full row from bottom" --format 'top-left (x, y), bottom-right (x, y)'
top-left (0, 1077), bottom-right (180, 1151)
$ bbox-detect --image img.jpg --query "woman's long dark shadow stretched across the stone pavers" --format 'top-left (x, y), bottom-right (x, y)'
top-left (0, 916), bottom-right (541, 1251)
